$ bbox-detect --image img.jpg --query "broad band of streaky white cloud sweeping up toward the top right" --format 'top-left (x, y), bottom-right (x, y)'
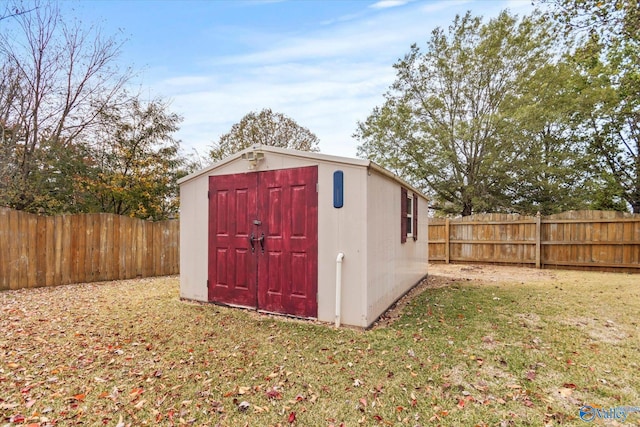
top-left (157, 0), bottom-right (528, 157)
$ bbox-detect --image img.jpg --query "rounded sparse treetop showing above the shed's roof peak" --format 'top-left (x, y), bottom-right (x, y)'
top-left (209, 108), bottom-right (319, 161)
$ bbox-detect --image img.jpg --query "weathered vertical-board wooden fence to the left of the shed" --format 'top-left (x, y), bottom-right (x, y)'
top-left (0, 208), bottom-right (180, 290)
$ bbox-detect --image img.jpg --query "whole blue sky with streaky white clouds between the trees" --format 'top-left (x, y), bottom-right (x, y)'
top-left (61, 0), bottom-right (532, 157)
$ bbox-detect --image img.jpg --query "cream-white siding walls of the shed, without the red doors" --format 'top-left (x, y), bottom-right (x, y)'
top-left (180, 147), bottom-right (427, 327)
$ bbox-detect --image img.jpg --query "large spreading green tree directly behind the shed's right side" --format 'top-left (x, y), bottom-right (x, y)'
top-left (355, 12), bottom-right (552, 215)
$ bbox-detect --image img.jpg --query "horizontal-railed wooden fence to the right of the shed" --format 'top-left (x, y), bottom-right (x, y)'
top-left (429, 211), bottom-right (640, 273)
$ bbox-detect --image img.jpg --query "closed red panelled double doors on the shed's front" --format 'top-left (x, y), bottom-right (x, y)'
top-left (208, 166), bottom-right (318, 317)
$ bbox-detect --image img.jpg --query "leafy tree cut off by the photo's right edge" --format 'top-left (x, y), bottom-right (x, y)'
top-left (548, 0), bottom-right (640, 213)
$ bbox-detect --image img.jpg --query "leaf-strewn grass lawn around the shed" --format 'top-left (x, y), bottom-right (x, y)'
top-left (0, 267), bottom-right (640, 427)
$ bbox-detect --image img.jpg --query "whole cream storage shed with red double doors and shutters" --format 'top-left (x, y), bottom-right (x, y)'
top-left (179, 146), bottom-right (428, 327)
